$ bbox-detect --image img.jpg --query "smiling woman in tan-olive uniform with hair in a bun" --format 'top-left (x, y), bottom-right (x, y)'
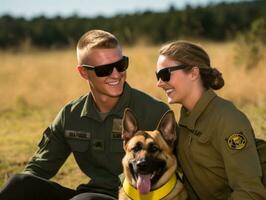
top-left (156, 41), bottom-right (266, 200)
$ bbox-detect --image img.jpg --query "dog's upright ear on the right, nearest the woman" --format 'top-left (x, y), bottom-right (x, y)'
top-left (157, 110), bottom-right (176, 147)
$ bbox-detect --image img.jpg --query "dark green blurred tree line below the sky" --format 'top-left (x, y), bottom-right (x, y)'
top-left (0, 0), bottom-right (266, 49)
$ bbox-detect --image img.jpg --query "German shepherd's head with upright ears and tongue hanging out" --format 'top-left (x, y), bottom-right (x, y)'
top-left (122, 110), bottom-right (176, 194)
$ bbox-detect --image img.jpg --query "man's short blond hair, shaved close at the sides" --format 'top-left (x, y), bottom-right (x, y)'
top-left (77, 30), bottom-right (120, 64)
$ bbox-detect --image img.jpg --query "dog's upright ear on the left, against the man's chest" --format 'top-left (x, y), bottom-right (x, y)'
top-left (122, 108), bottom-right (138, 143)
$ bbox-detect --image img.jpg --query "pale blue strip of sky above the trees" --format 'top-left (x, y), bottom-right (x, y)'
top-left (0, 0), bottom-right (241, 18)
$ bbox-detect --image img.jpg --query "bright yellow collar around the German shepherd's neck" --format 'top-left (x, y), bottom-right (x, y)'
top-left (123, 174), bottom-right (177, 200)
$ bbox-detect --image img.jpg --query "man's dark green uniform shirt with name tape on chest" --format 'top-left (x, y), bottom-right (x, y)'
top-left (24, 83), bottom-right (169, 196)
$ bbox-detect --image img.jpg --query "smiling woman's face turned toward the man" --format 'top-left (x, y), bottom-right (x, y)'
top-left (156, 55), bottom-right (193, 105)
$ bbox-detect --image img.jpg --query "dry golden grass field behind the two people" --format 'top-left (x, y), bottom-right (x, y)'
top-left (0, 41), bottom-right (266, 188)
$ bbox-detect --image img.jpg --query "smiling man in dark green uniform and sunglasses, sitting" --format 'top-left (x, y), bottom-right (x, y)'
top-left (0, 30), bottom-right (169, 200)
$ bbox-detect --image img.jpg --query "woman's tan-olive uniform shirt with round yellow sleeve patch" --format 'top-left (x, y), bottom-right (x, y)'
top-left (177, 90), bottom-right (266, 200)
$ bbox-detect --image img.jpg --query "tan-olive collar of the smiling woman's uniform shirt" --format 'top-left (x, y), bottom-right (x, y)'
top-left (179, 89), bottom-right (217, 130)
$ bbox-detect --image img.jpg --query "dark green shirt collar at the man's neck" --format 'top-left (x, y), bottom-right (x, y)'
top-left (80, 82), bottom-right (131, 121)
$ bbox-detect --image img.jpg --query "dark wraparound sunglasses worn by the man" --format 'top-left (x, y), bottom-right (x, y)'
top-left (80, 56), bottom-right (128, 77)
